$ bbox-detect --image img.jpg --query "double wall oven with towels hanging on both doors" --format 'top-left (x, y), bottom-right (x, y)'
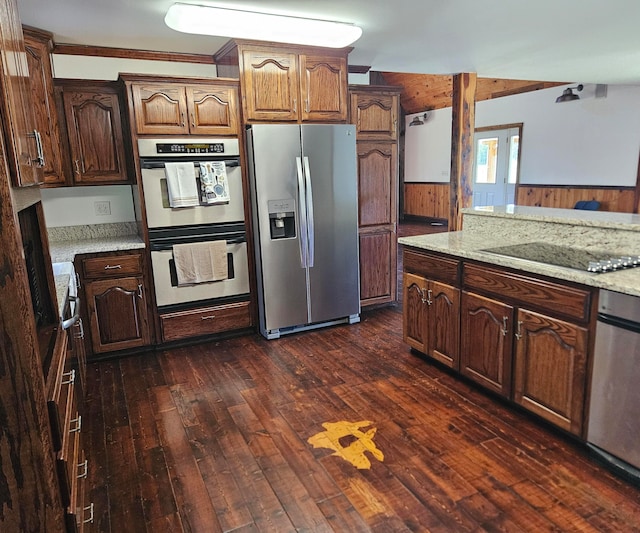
top-left (138, 137), bottom-right (249, 314)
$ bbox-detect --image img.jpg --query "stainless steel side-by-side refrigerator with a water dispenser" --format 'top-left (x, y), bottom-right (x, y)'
top-left (247, 124), bottom-right (360, 339)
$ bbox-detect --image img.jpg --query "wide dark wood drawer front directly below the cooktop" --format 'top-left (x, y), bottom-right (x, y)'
top-left (463, 264), bottom-right (591, 322)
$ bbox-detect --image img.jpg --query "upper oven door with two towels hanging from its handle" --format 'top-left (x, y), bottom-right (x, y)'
top-left (141, 160), bottom-right (244, 228)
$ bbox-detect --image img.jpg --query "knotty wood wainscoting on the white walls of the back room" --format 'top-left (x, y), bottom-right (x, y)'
top-left (402, 183), bottom-right (638, 219)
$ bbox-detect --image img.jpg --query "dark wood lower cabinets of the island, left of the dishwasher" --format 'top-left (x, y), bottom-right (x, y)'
top-left (403, 250), bottom-right (595, 436)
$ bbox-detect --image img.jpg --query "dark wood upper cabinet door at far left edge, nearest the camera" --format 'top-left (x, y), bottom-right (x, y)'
top-left (0, 0), bottom-right (44, 187)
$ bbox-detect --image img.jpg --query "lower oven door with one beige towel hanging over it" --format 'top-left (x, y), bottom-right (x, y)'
top-left (151, 242), bottom-right (249, 308)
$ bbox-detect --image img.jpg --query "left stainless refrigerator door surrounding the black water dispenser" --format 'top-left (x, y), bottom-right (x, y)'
top-left (248, 124), bottom-right (309, 334)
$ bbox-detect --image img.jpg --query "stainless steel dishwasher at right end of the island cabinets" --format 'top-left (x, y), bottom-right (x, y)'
top-left (587, 290), bottom-right (640, 481)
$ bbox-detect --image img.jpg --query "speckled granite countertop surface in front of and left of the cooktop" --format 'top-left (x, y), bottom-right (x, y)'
top-left (398, 231), bottom-right (640, 296)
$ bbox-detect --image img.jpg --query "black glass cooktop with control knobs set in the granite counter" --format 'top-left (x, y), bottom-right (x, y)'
top-left (481, 242), bottom-right (640, 274)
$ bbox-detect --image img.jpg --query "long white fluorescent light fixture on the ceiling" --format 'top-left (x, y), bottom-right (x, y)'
top-left (164, 3), bottom-right (362, 48)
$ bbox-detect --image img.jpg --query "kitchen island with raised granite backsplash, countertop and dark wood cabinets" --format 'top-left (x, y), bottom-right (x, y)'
top-left (398, 206), bottom-right (640, 439)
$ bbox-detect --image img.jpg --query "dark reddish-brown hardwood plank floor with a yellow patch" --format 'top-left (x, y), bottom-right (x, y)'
top-left (83, 221), bottom-right (640, 533)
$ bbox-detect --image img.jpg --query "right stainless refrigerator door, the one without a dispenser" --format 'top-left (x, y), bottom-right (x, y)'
top-left (301, 124), bottom-right (360, 322)
